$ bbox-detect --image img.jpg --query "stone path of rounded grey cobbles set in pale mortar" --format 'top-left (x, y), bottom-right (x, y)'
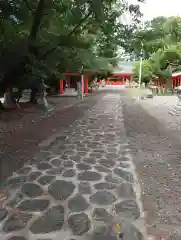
top-left (0, 93), bottom-right (148, 240)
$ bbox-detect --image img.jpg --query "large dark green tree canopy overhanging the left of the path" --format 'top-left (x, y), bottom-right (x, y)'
top-left (0, 0), bottom-right (141, 91)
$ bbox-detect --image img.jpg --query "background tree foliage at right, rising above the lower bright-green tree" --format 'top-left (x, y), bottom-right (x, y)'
top-left (124, 17), bottom-right (181, 59)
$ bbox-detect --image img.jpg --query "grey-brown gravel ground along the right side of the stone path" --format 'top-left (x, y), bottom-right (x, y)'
top-left (122, 94), bottom-right (181, 240)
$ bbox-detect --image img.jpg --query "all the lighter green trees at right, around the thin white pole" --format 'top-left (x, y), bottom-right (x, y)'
top-left (129, 17), bottom-right (181, 87)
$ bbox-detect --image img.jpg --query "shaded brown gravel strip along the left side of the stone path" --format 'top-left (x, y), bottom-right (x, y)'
top-left (0, 93), bottom-right (100, 183)
